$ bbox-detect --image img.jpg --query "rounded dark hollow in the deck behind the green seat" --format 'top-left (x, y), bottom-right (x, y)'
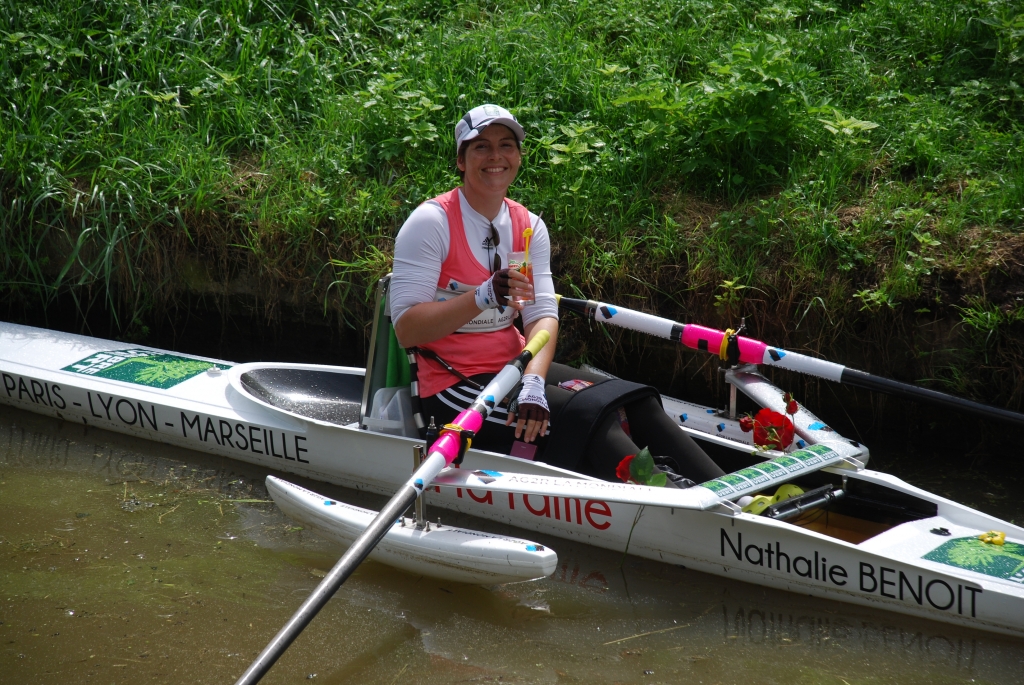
top-left (231, 363), bottom-right (364, 426)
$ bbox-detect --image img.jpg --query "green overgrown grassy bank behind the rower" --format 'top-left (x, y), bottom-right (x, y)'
top-left (0, 0), bottom-right (1024, 409)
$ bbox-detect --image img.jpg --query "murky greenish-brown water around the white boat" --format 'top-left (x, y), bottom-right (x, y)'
top-left (0, 408), bottom-right (1024, 685)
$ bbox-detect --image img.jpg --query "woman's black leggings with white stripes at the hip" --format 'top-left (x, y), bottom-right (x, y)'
top-left (422, 363), bottom-right (725, 483)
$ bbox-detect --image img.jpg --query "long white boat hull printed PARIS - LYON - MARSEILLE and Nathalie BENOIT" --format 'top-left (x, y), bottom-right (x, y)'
top-left (0, 324), bottom-right (1024, 637)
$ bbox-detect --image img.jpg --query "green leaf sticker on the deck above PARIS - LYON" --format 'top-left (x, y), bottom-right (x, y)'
top-left (61, 347), bottom-right (229, 390)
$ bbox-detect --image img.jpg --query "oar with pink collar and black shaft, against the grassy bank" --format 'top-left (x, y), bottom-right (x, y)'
top-left (558, 297), bottom-right (1024, 425)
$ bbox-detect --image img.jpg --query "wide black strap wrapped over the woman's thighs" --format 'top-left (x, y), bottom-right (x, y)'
top-left (543, 378), bottom-right (662, 470)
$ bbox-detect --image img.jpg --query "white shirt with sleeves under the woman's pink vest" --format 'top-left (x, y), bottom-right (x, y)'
top-left (390, 189), bottom-right (558, 324)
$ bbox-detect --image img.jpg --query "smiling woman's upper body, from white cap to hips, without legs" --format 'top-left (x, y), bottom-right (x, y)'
top-left (391, 104), bottom-right (558, 453)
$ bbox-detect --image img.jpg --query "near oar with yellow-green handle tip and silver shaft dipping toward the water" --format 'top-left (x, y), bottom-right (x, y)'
top-left (236, 331), bottom-right (551, 685)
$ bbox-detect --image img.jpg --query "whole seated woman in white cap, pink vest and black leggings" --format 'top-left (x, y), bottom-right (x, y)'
top-left (390, 104), bottom-right (722, 481)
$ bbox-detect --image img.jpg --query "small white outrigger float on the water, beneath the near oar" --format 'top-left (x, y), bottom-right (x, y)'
top-left (266, 476), bottom-right (558, 585)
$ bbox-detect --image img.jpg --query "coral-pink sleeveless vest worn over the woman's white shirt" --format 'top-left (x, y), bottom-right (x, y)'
top-left (417, 188), bottom-right (529, 397)
